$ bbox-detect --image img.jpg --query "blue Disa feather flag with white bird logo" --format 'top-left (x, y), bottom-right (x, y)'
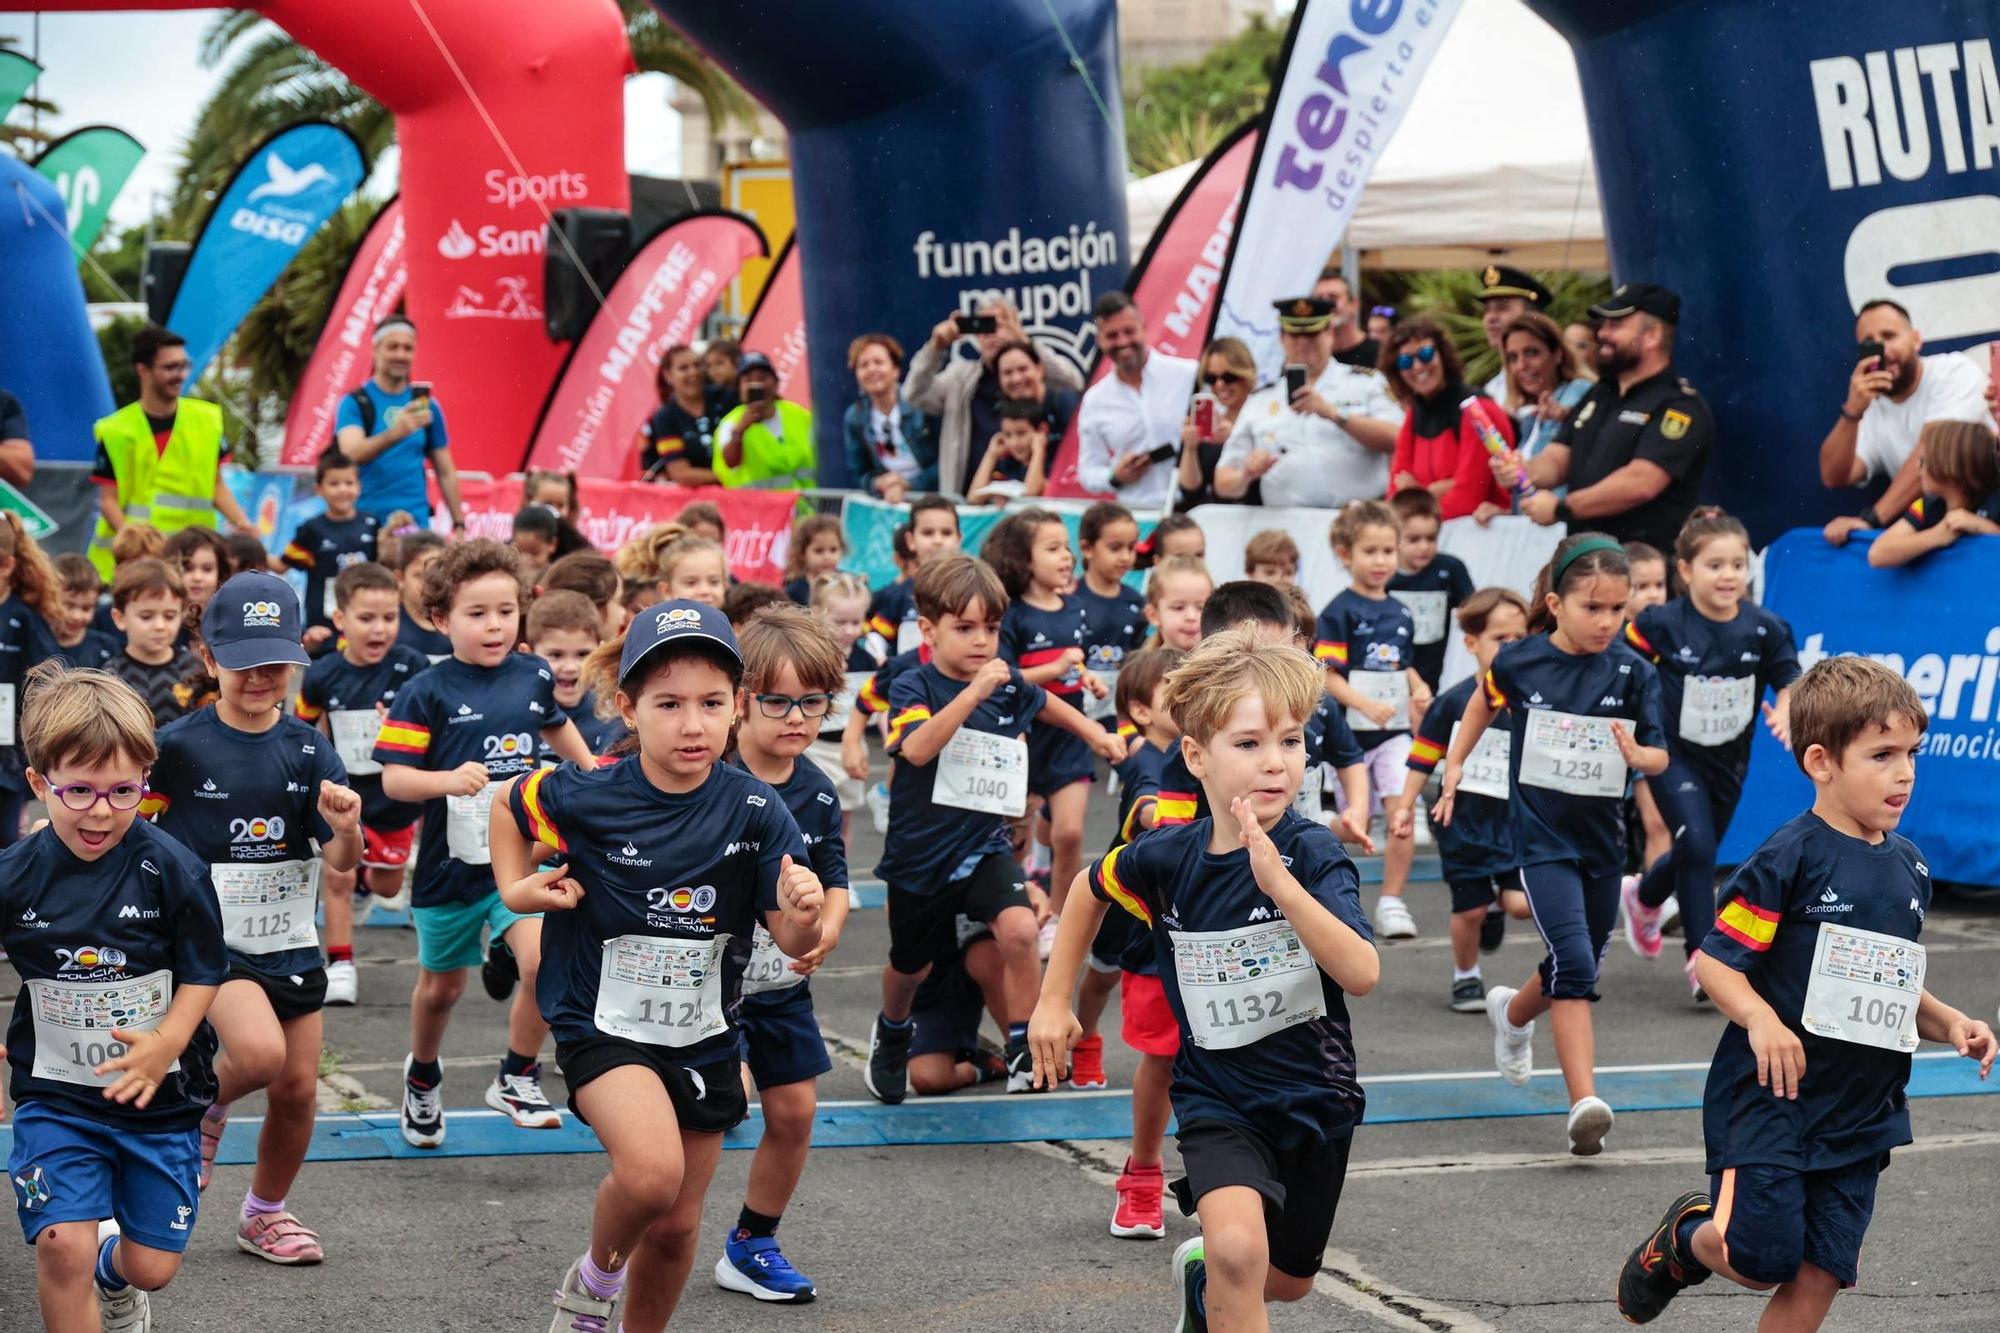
top-left (166, 120), bottom-right (368, 380)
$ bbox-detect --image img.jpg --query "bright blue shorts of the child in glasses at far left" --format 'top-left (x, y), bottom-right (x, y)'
top-left (6, 1101), bottom-right (202, 1255)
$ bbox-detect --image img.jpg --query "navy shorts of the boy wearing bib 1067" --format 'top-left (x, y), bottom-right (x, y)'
top-left (1708, 1153), bottom-right (1888, 1287)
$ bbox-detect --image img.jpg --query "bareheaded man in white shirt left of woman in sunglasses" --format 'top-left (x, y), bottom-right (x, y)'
top-left (1076, 292), bottom-right (1198, 510)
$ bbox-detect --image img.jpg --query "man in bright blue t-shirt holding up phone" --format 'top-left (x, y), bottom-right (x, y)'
top-left (334, 314), bottom-right (466, 528)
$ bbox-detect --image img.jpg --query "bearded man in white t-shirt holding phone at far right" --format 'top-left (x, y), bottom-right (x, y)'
top-left (1820, 300), bottom-right (1990, 546)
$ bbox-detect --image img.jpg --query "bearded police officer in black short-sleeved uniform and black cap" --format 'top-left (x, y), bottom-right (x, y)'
top-left (1494, 282), bottom-right (1716, 550)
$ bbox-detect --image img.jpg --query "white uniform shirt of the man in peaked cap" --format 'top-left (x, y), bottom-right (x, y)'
top-left (1216, 360), bottom-right (1402, 508)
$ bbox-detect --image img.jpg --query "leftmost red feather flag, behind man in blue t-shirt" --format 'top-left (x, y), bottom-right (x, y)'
top-left (280, 196), bottom-right (410, 466)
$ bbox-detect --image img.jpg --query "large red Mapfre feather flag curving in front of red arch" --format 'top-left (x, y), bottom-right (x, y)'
top-left (526, 212), bottom-right (770, 480)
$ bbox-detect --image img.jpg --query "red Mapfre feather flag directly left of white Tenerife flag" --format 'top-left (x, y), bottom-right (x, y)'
top-left (1048, 122), bottom-right (1258, 496)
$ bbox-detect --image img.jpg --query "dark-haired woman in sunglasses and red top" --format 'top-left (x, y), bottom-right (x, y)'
top-left (1382, 318), bottom-right (1514, 522)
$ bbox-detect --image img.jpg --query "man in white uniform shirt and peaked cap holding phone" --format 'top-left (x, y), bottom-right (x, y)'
top-left (1216, 296), bottom-right (1402, 508)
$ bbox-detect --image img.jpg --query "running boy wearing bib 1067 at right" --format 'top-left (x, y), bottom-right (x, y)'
top-left (1618, 656), bottom-right (1994, 1333)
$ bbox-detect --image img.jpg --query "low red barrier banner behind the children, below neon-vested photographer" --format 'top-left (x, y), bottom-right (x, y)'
top-left (444, 472), bottom-right (798, 584)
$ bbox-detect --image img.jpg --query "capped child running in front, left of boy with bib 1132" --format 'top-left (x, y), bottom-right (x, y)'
top-left (492, 600), bottom-right (824, 1333)
